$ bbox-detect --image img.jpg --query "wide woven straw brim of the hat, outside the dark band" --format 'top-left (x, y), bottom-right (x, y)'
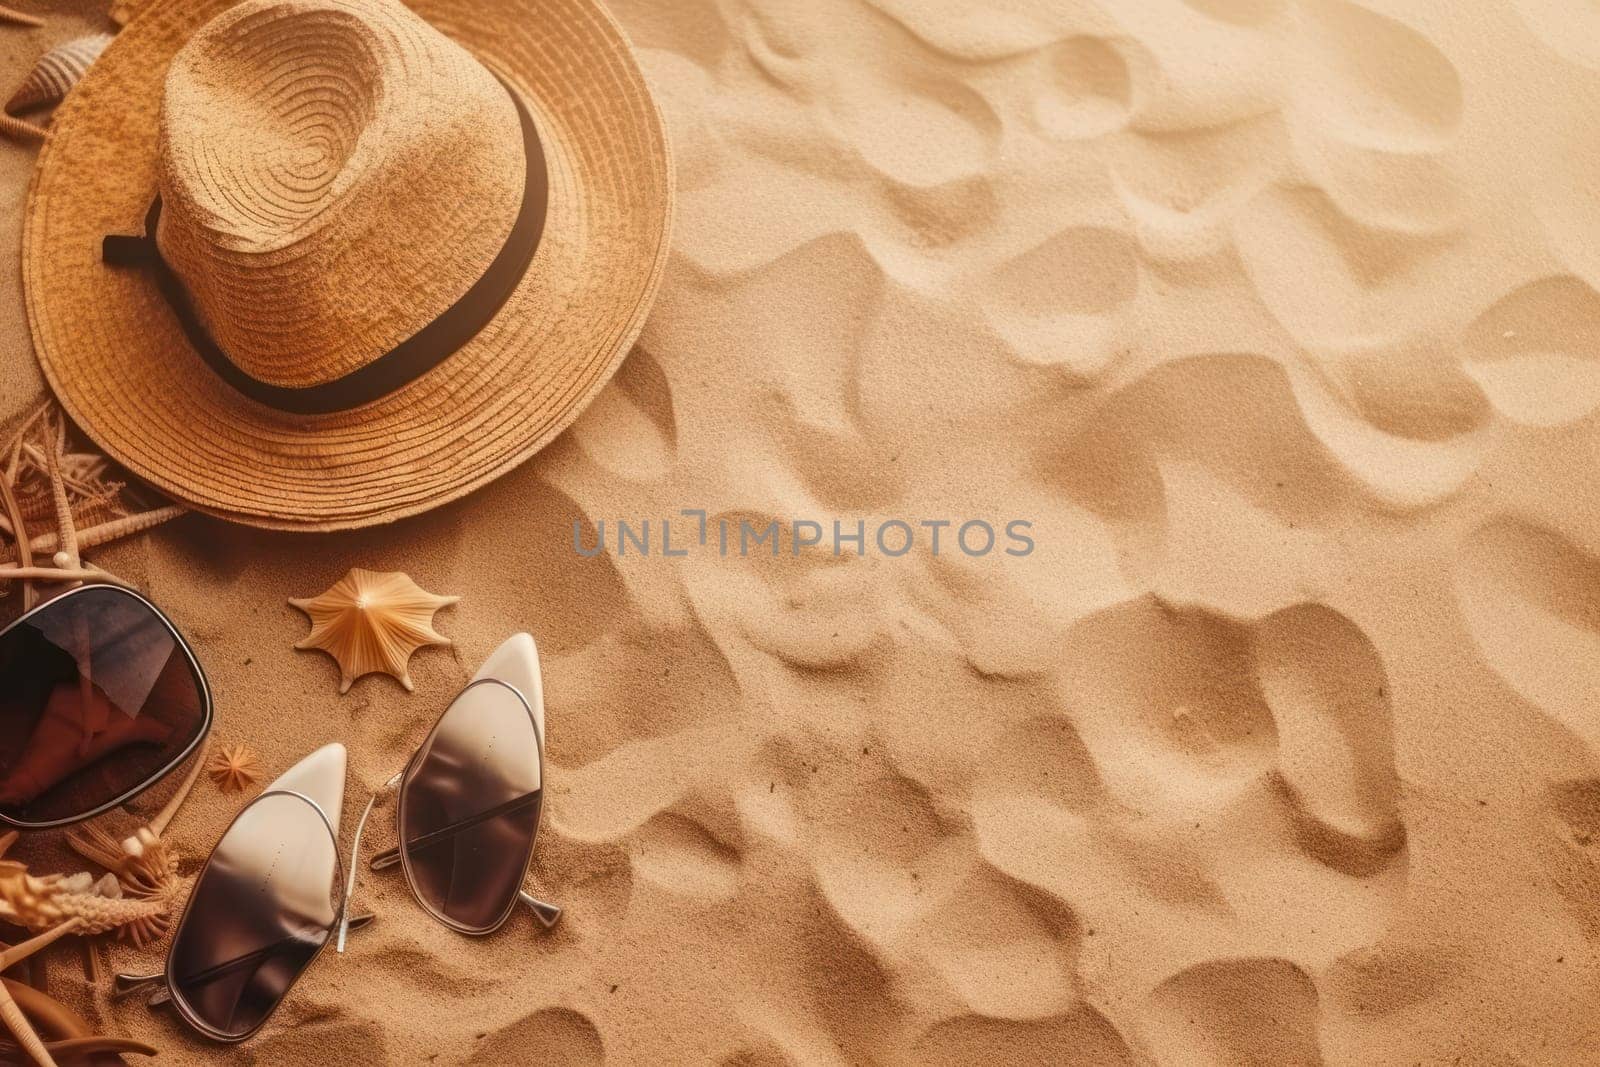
top-left (22, 0), bottom-right (672, 530)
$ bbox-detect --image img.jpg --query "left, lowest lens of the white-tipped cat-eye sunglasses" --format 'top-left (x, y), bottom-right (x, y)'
top-left (166, 793), bottom-right (339, 1040)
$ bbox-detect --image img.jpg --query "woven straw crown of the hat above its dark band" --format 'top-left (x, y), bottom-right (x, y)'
top-left (157, 0), bottom-right (526, 387)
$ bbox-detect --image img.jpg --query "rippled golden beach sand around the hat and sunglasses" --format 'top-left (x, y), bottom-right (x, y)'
top-left (0, 0), bottom-right (1600, 1067)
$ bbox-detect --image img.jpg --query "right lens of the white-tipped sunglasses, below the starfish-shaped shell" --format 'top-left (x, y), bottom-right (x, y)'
top-left (400, 681), bottom-right (542, 933)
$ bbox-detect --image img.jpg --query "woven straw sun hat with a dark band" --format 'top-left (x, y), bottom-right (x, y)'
top-left (22, 0), bottom-right (672, 530)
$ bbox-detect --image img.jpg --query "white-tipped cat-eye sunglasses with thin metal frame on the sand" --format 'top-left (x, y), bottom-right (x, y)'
top-left (117, 633), bottom-right (562, 1043)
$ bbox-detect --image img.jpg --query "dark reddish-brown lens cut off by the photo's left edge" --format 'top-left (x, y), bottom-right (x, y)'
top-left (0, 585), bottom-right (206, 825)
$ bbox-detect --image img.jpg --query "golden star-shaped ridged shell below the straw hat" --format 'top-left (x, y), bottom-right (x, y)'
top-left (290, 566), bottom-right (461, 693)
